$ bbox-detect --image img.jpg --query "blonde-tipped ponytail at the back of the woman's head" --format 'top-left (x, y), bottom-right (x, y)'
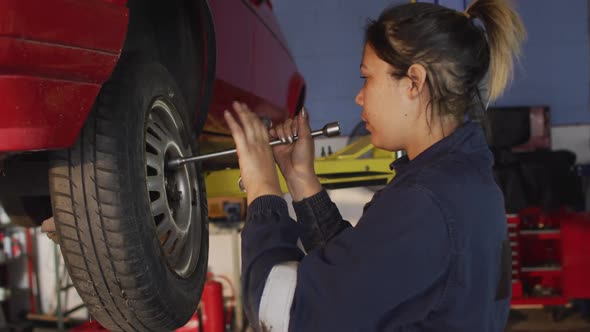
top-left (465, 0), bottom-right (526, 101)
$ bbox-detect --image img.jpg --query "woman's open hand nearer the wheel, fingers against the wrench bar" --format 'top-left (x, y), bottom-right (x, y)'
top-left (224, 102), bottom-right (282, 205)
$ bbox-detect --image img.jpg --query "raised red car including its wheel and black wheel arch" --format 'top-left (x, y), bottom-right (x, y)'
top-left (0, 0), bottom-right (305, 331)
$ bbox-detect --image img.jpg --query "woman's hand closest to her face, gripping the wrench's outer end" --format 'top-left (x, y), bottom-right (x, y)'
top-left (270, 108), bottom-right (322, 201)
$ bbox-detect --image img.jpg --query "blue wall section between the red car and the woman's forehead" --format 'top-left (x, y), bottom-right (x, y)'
top-left (273, 0), bottom-right (407, 134)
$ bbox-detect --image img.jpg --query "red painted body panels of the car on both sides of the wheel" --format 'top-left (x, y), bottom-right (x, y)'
top-left (0, 0), bottom-right (304, 153)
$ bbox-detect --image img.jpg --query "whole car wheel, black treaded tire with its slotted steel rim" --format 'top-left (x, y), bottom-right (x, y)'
top-left (49, 58), bottom-right (208, 332)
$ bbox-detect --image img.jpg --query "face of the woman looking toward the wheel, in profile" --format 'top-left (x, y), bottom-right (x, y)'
top-left (355, 44), bottom-right (416, 151)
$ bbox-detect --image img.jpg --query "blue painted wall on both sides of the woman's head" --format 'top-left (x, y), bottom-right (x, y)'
top-left (273, 0), bottom-right (590, 134)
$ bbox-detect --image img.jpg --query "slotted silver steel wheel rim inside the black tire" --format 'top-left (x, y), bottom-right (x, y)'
top-left (145, 98), bottom-right (202, 277)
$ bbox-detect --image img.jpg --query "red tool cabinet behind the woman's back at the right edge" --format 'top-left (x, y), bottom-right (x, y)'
top-left (507, 207), bottom-right (590, 307)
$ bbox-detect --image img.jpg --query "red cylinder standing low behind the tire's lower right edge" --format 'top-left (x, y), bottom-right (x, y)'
top-left (201, 275), bottom-right (224, 332)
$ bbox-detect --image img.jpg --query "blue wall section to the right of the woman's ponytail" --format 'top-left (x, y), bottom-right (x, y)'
top-left (497, 0), bottom-right (590, 125)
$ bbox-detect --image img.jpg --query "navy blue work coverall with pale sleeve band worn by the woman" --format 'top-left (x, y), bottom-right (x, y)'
top-left (242, 122), bottom-right (511, 332)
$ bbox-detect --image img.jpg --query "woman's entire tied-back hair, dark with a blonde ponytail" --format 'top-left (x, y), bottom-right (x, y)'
top-left (365, 0), bottom-right (526, 123)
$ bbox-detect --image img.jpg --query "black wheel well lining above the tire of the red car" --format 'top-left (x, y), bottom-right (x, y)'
top-left (123, 0), bottom-right (215, 132)
